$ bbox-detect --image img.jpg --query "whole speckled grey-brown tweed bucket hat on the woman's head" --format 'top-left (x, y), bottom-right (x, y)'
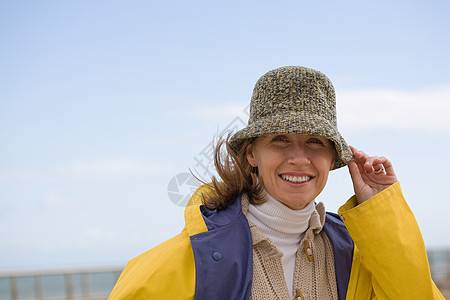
top-left (229, 66), bottom-right (353, 169)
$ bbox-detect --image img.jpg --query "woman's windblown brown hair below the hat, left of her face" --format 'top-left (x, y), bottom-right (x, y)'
top-left (202, 134), bottom-right (264, 210)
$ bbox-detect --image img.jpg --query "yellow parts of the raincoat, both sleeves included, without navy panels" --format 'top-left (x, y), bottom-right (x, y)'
top-left (109, 183), bottom-right (444, 300)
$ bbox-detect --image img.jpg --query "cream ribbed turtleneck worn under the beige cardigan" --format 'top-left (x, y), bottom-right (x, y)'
top-left (247, 192), bottom-right (316, 295)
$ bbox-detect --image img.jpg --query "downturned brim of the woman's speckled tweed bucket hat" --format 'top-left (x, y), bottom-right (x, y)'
top-left (229, 112), bottom-right (354, 170)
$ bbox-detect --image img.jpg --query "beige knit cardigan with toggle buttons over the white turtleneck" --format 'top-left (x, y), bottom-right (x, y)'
top-left (242, 197), bottom-right (338, 300)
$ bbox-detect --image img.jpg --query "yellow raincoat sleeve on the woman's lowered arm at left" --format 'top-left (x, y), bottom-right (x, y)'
top-left (108, 231), bottom-right (195, 300)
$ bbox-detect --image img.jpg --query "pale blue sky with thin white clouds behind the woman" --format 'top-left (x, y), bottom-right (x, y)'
top-left (0, 0), bottom-right (450, 270)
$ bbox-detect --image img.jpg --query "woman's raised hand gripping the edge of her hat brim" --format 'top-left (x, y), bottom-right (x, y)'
top-left (346, 146), bottom-right (398, 204)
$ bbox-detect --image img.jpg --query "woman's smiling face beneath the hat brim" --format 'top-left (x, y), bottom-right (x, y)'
top-left (247, 134), bottom-right (335, 209)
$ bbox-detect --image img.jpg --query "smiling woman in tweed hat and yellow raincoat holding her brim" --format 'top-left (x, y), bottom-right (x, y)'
top-left (110, 67), bottom-right (443, 299)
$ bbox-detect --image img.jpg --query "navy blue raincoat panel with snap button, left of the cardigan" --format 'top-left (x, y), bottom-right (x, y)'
top-left (191, 197), bottom-right (253, 300)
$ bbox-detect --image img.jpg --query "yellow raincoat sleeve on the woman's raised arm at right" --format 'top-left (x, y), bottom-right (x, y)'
top-left (339, 182), bottom-right (444, 299)
